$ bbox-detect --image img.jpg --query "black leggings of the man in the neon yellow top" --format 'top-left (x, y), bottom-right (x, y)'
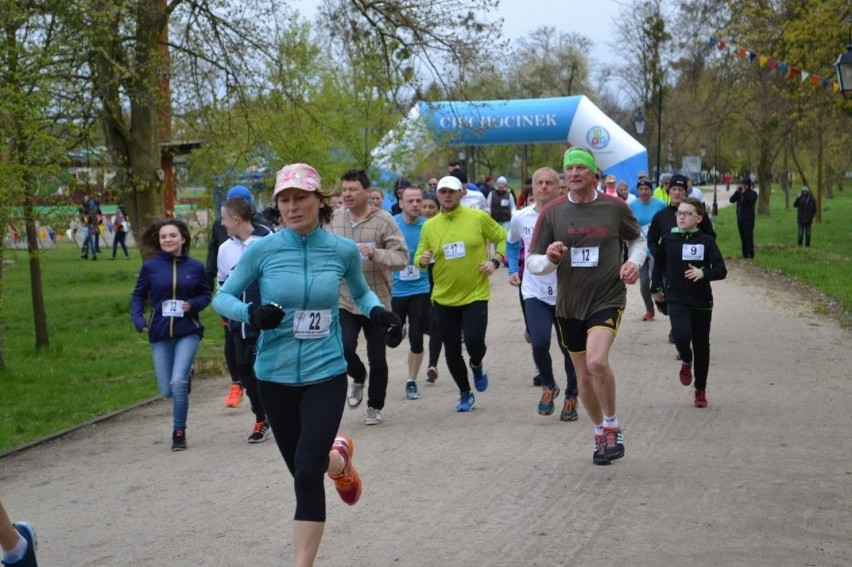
top-left (432, 301), bottom-right (488, 393)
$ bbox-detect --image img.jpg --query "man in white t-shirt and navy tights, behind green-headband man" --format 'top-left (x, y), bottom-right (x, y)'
top-left (506, 167), bottom-right (577, 421)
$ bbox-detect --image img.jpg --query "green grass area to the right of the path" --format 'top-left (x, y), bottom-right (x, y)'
top-left (708, 187), bottom-right (852, 325)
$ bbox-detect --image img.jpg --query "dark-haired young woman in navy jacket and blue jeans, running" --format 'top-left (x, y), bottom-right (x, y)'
top-left (130, 219), bottom-right (215, 451)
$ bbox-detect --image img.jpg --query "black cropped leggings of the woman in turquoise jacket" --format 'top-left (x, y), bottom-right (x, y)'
top-left (257, 374), bottom-right (347, 522)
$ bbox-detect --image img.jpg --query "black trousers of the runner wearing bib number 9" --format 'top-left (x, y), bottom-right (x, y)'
top-left (669, 303), bottom-right (713, 390)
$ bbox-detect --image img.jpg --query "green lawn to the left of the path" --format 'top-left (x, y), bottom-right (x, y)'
top-left (0, 242), bottom-right (222, 453)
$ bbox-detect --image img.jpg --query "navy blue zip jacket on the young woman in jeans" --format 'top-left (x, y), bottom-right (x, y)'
top-left (130, 252), bottom-right (210, 343)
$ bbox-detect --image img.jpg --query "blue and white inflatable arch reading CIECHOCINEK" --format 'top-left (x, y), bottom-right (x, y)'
top-left (371, 95), bottom-right (648, 188)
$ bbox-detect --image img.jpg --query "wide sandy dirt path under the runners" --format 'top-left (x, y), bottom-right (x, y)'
top-left (0, 265), bottom-right (852, 567)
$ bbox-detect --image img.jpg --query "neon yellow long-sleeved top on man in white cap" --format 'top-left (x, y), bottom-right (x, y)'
top-left (414, 206), bottom-right (506, 307)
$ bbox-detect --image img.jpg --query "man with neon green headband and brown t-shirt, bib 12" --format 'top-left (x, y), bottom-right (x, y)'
top-left (526, 148), bottom-right (647, 465)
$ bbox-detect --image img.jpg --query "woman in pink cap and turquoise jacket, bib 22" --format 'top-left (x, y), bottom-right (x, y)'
top-left (213, 163), bottom-right (400, 567)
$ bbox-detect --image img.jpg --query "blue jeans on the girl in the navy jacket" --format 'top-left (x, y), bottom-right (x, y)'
top-left (151, 334), bottom-right (201, 429)
